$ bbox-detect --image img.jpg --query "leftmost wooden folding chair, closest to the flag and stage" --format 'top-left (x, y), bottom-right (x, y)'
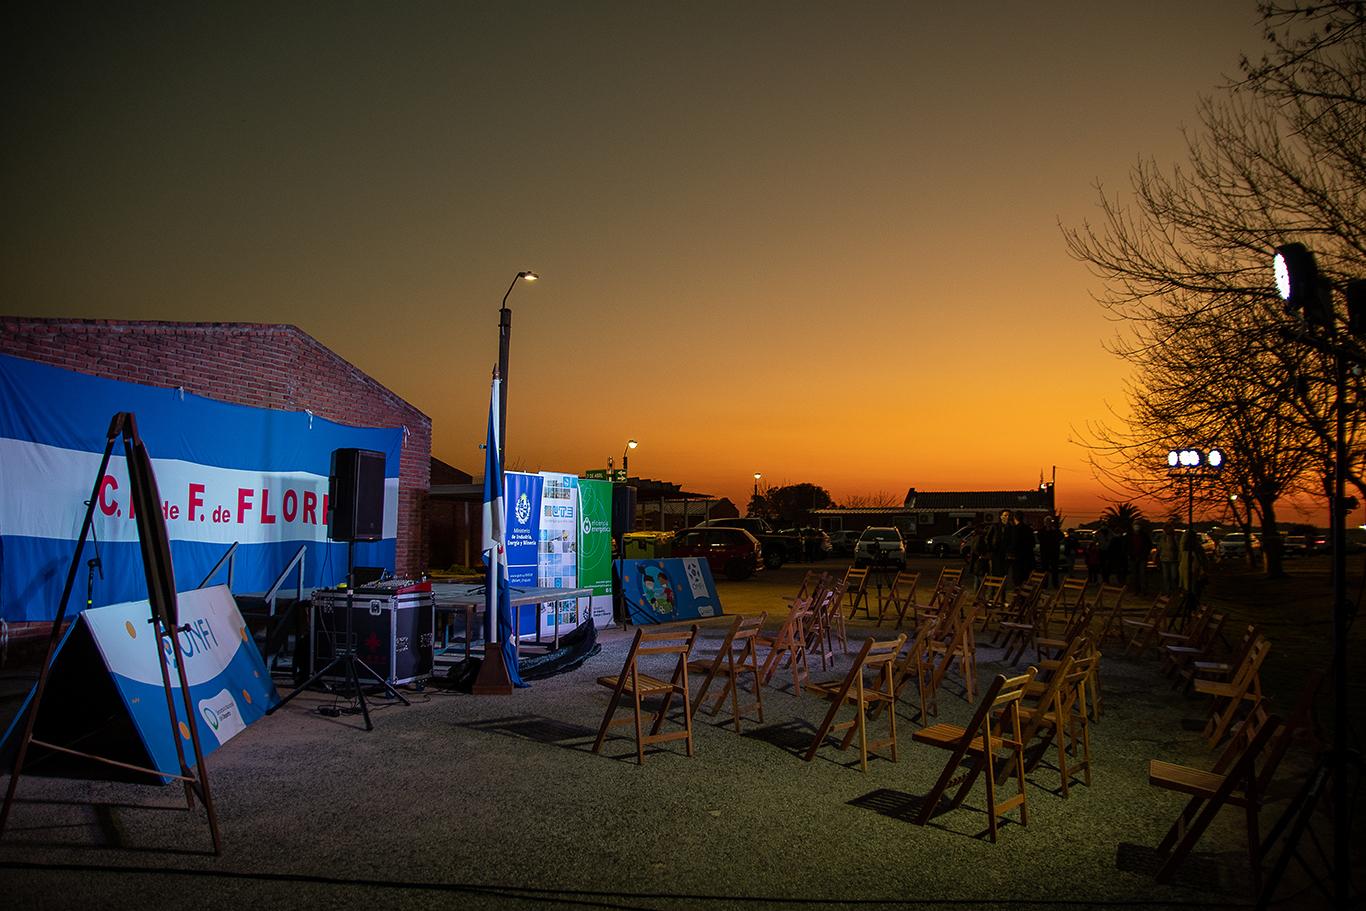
top-left (593, 626), bottom-right (697, 763)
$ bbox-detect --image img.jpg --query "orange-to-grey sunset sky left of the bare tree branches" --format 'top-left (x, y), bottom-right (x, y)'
top-left (0, 0), bottom-right (1284, 523)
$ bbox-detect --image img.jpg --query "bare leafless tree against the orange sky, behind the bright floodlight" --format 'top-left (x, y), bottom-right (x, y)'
top-left (1063, 3), bottom-right (1366, 572)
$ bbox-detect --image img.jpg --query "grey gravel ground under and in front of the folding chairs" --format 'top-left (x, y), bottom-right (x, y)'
top-left (0, 564), bottom-right (1344, 911)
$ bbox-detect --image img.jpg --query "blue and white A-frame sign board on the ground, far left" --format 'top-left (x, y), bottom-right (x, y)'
top-left (0, 585), bottom-right (279, 783)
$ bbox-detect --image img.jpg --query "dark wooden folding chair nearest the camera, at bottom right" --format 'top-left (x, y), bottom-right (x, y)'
top-left (1147, 712), bottom-right (1288, 893)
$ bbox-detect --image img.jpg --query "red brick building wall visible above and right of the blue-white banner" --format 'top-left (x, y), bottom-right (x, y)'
top-left (0, 317), bottom-right (432, 576)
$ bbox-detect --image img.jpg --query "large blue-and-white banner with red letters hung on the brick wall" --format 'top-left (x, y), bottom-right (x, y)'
top-left (0, 355), bottom-right (403, 620)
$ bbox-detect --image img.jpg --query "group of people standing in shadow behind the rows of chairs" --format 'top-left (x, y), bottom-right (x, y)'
top-left (966, 509), bottom-right (1203, 594)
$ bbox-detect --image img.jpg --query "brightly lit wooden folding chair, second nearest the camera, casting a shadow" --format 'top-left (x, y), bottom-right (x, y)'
top-left (912, 668), bottom-right (1035, 843)
